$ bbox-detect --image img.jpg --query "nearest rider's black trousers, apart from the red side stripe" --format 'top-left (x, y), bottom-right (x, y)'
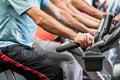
top-left (0, 45), bottom-right (63, 80)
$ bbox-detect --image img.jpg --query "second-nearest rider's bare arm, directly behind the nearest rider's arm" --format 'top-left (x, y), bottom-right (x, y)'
top-left (44, 5), bottom-right (96, 35)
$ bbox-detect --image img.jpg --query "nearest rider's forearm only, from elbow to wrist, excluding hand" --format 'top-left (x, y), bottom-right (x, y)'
top-left (38, 16), bottom-right (76, 40)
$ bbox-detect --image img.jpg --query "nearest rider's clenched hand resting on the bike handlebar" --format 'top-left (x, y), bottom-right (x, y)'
top-left (74, 33), bottom-right (94, 48)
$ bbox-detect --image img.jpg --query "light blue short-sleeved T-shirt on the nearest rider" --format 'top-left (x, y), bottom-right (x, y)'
top-left (0, 0), bottom-right (50, 49)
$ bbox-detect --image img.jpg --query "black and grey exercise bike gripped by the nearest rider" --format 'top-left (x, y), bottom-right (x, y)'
top-left (56, 14), bottom-right (120, 80)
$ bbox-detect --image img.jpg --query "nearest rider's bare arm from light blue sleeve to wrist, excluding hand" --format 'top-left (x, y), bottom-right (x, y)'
top-left (26, 7), bottom-right (77, 40)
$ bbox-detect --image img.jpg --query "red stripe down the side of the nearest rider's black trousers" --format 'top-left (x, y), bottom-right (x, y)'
top-left (0, 52), bottom-right (49, 80)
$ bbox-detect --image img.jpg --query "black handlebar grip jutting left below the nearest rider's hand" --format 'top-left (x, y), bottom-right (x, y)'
top-left (56, 42), bottom-right (80, 52)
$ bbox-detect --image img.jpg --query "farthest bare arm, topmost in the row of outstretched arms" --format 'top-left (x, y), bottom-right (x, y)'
top-left (70, 0), bottom-right (105, 19)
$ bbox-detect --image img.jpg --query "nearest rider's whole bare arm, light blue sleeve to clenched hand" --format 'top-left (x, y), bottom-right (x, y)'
top-left (25, 7), bottom-right (94, 47)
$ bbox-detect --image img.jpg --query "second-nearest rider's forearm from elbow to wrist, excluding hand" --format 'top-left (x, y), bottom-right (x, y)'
top-left (54, 11), bottom-right (88, 32)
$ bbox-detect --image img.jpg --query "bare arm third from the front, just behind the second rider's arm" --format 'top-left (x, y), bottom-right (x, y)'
top-left (51, 0), bottom-right (99, 28)
